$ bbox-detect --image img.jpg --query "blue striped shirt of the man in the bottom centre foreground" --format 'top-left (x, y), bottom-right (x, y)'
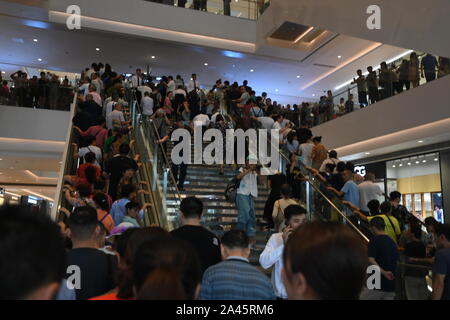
top-left (199, 257), bottom-right (275, 300)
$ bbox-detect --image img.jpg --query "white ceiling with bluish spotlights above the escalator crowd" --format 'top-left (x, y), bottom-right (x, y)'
top-left (0, 16), bottom-right (406, 103)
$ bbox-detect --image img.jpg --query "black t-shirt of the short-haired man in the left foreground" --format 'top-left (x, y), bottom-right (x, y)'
top-left (66, 248), bottom-right (117, 300)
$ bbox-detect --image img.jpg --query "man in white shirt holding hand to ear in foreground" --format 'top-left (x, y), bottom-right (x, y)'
top-left (259, 205), bottom-right (306, 299)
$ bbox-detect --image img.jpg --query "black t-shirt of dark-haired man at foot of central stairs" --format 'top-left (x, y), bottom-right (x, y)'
top-left (171, 226), bottom-right (222, 273)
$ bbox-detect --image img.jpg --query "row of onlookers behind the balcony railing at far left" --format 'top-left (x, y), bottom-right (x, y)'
top-left (0, 70), bottom-right (73, 110)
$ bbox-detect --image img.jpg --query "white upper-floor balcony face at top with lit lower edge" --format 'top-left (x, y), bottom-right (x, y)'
top-left (49, 0), bottom-right (256, 50)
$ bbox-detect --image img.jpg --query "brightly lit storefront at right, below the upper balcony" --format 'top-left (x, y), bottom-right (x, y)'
top-left (355, 152), bottom-right (444, 222)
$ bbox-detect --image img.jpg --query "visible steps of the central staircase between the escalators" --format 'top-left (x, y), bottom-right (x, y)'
top-left (167, 142), bottom-right (270, 266)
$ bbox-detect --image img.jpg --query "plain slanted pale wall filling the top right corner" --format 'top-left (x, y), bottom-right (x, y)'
top-left (268, 0), bottom-right (450, 57)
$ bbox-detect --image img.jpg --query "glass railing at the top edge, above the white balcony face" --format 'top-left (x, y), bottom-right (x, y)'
top-left (143, 0), bottom-right (270, 20)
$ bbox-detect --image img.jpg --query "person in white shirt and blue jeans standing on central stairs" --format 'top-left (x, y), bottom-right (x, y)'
top-left (236, 155), bottom-right (258, 245)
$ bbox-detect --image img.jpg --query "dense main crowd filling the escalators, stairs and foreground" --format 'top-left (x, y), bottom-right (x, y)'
top-left (0, 58), bottom-right (450, 300)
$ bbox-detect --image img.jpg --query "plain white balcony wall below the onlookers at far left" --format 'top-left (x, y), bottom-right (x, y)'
top-left (0, 106), bottom-right (70, 141)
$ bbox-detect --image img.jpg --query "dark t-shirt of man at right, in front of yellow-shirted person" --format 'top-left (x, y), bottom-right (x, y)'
top-left (368, 235), bottom-right (399, 292)
